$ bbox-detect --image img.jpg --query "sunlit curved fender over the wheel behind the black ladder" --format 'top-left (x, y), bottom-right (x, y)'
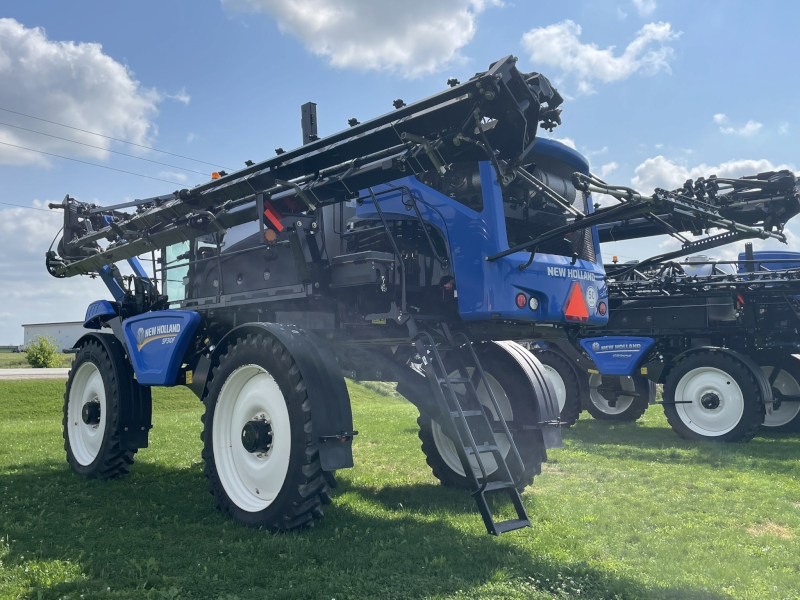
top-left (481, 342), bottom-right (563, 448)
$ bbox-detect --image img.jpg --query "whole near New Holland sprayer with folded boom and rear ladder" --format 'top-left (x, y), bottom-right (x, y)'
top-left (47, 57), bottom-right (780, 535)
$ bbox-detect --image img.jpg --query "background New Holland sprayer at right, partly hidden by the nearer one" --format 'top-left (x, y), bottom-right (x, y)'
top-left (533, 171), bottom-right (800, 442)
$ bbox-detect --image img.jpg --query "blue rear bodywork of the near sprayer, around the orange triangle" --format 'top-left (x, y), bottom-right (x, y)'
top-left (357, 139), bottom-right (608, 325)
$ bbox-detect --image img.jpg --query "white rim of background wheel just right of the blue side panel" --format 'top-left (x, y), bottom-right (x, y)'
top-left (675, 367), bottom-right (744, 437)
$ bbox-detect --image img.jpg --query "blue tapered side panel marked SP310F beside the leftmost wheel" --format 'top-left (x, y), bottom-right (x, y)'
top-left (122, 310), bottom-right (200, 386)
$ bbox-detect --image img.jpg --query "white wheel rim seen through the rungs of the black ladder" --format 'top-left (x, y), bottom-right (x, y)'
top-left (431, 367), bottom-right (514, 477)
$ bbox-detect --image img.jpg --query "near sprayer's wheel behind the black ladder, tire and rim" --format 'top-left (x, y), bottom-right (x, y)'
top-left (417, 357), bottom-right (546, 490)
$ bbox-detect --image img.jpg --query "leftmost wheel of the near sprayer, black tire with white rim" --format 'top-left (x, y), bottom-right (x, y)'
top-left (61, 340), bottom-right (138, 479)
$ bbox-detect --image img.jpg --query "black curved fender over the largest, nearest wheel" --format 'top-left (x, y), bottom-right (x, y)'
top-left (208, 322), bottom-right (355, 471)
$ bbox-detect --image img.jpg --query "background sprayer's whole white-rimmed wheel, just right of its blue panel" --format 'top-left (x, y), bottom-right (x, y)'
top-left (664, 352), bottom-right (765, 442)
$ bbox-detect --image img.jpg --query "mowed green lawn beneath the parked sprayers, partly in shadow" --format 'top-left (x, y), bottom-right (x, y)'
top-left (0, 381), bottom-right (800, 600)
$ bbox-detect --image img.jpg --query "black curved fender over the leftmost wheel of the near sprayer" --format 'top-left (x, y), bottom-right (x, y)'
top-left (74, 331), bottom-right (153, 450)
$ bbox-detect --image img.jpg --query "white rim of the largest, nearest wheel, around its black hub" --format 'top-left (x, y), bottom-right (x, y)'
top-left (212, 365), bottom-right (292, 512)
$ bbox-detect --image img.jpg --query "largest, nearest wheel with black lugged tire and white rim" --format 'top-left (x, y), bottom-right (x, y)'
top-left (200, 334), bottom-right (336, 531)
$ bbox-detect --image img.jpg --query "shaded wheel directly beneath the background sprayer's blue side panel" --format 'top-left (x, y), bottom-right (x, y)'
top-left (586, 373), bottom-right (653, 423)
